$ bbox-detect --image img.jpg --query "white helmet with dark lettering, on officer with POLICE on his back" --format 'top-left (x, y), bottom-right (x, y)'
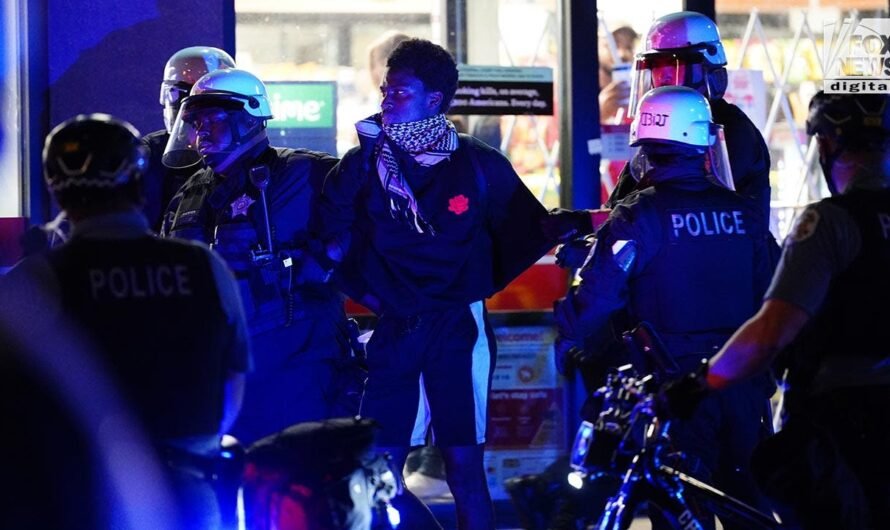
top-left (630, 86), bottom-right (735, 190)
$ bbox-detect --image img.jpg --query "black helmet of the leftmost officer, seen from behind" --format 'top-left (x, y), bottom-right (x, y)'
top-left (43, 114), bottom-right (148, 210)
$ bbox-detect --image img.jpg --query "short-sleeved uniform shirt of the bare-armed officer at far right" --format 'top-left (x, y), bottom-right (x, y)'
top-left (765, 179), bottom-right (890, 392)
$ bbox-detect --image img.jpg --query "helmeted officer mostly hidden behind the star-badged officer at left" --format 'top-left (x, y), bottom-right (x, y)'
top-left (142, 46), bottom-right (235, 230)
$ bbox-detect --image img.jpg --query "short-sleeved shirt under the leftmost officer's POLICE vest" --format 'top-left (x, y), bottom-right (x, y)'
top-left (0, 211), bottom-right (252, 452)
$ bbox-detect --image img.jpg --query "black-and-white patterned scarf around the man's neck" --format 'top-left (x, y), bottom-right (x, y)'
top-left (355, 114), bottom-right (458, 235)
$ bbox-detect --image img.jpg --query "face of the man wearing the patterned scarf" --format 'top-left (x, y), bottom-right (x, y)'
top-left (380, 70), bottom-right (442, 125)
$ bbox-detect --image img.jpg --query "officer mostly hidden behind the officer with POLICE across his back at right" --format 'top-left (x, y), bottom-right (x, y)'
top-left (548, 11), bottom-right (778, 243)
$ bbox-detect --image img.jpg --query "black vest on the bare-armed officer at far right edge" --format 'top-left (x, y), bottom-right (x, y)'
top-left (800, 190), bottom-right (890, 358)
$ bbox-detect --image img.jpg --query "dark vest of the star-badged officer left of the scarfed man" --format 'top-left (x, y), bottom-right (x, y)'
top-left (169, 148), bottom-right (345, 335)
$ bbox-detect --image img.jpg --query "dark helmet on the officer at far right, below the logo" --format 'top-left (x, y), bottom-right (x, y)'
top-left (807, 91), bottom-right (890, 195)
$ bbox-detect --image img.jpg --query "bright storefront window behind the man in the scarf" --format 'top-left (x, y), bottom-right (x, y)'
top-left (235, 0), bottom-right (559, 207)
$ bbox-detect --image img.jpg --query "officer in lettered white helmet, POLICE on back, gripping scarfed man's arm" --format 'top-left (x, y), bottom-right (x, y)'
top-left (555, 87), bottom-right (771, 527)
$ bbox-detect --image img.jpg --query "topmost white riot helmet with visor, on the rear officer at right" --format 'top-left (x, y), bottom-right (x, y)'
top-left (629, 11), bottom-right (727, 116)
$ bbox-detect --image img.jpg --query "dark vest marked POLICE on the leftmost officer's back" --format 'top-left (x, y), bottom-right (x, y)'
top-left (48, 237), bottom-right (227, 440)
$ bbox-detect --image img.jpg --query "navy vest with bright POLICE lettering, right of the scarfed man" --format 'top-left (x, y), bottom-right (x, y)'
top-left (629, 184), bottom-right (765, 342)
